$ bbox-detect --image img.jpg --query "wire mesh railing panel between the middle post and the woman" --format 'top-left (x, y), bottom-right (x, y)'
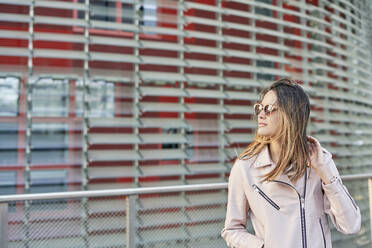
top-left (136, 191), bottom-right (227, 247)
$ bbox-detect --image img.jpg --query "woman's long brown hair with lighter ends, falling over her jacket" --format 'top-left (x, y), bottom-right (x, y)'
top-left (238, 78), bottom-right (310, 182)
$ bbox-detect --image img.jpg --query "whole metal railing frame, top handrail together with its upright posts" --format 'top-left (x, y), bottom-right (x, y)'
top-left (0, 173), bottom-right (372, 248)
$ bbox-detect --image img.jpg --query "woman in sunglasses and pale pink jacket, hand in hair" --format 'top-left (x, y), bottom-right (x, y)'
top-left (221, 79), bottom-right (361, 248)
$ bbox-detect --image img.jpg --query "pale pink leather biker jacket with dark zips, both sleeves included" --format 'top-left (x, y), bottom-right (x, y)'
top-left (221, 146), bottom-right (361, 248)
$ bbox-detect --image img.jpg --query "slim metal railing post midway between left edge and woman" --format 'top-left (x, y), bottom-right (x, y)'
top-left (126, 195), bottom-right (136, 248)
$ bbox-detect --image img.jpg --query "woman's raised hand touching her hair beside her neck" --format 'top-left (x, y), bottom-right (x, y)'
top-left (307, 136), bottom-right (331, 184)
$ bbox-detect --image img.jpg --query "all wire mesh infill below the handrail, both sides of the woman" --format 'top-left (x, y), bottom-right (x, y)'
top-left (0, 180), bottom-right (372, 248)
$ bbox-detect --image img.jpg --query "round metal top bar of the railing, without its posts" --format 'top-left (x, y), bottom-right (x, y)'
top-left (0, 173), bottom-right (372, 203)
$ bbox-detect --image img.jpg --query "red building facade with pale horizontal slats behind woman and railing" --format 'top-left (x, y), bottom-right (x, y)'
top-left (0, 0), bottom-right (372, 248)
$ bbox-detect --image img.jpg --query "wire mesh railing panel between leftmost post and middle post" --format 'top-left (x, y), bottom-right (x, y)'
top-left (8, 197), bottom-right (126, 248)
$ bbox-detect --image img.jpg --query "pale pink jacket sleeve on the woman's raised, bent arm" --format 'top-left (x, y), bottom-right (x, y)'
top-left (322, 150), bottom-right (361, 234)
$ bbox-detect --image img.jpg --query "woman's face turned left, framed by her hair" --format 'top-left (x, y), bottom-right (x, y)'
top-left (257, 90), bottom-right (280, 137)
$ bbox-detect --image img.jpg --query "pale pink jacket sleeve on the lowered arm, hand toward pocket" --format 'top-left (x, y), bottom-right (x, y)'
top-left (221, 160), bottom-right (264, 248)
